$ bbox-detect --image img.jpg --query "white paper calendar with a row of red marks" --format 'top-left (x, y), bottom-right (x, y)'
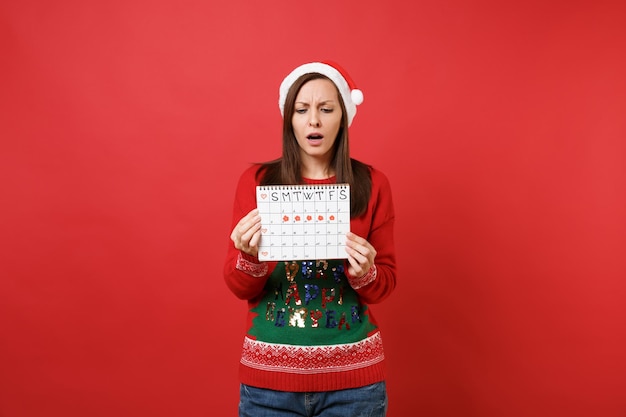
top-left (256, 184), bottom-right (350, 261)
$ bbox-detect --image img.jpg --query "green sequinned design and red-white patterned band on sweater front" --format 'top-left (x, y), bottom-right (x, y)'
top-left (242, 260), bottom-right (384, 373)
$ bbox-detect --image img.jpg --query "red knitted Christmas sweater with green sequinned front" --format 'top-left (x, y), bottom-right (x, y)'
top-left (224, 165), bottom-right (396, 392)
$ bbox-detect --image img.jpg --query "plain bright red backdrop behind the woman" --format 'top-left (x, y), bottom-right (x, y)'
top-left (0, 0), bottom-right (626, 417)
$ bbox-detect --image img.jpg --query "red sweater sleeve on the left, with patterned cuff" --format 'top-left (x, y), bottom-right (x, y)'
top-left (224, 165), bottom-right (275, 300)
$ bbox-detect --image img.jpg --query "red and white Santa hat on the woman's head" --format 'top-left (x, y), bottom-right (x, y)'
top-left (278, 61), bottom-right (363, 126)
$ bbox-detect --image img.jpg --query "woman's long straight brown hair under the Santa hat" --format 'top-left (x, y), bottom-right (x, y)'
top-left (257, 72), bottom-right (372, 218)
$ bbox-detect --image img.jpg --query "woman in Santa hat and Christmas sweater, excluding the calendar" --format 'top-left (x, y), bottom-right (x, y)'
top-left (224, 62), bottom-right (396, 417)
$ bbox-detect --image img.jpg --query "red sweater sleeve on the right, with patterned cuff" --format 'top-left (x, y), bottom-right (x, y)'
top-left (346, 169), bottom-right (396, 304)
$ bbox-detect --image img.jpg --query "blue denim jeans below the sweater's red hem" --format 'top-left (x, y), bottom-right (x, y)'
top-left (239, 382), bottom-right (387, 417)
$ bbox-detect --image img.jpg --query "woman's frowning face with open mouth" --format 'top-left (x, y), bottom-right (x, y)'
top-left (292, 78), bottom-right (342, 164)
